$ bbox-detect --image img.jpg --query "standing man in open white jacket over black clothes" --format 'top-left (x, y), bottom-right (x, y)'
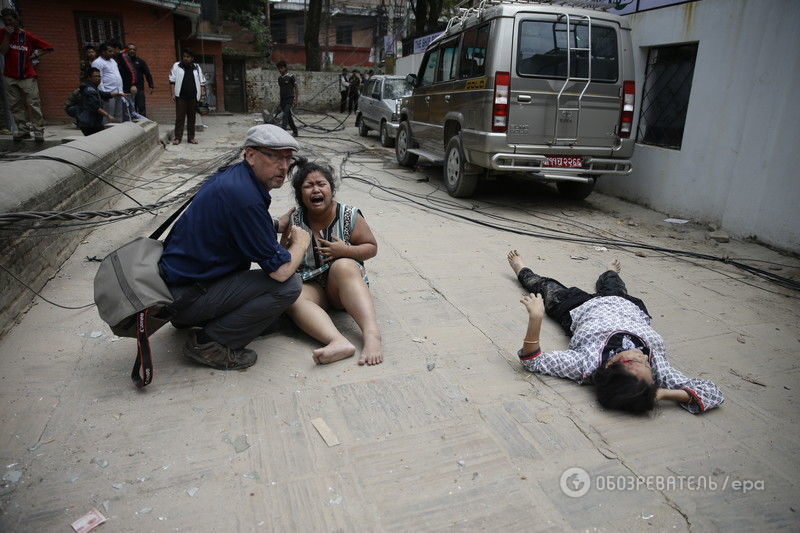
top-left (169, 48), bottom-right (206, 144)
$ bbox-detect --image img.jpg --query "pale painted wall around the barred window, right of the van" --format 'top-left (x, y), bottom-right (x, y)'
top-left (598, 0), bottom-right (800, 252)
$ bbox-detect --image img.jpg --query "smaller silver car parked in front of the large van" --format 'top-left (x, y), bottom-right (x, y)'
top-left (356, 74), bottom-right (412, 146)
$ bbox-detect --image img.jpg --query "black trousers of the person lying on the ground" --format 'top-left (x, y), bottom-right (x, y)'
top-left (517, 267), bottom-right (650, 336)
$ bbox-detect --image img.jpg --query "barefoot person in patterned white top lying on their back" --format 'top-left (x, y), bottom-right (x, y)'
top-left (508, 250), bottom-right (725, 414)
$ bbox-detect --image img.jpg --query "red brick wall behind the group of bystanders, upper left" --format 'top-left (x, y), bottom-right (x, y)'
top-left (21, 0), bottom-right (180, 123)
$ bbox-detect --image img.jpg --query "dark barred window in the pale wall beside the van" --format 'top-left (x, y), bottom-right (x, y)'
top-left (636, 43), bottom-right (697, 150)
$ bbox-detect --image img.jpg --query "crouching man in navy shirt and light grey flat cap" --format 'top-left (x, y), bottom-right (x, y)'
top-left (159, 124), bottom-right (311, 370)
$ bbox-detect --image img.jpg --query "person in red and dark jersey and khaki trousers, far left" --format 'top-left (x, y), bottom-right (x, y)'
top-left (0, 8), bottom-right (53, 143)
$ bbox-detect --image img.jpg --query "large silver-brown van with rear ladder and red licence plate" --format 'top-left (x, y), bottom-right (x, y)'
top-left (395, 0), bottom-right (635, 199)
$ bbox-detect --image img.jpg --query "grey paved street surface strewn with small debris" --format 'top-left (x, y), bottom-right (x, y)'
top-left (0, 116), bottom-right (800, 531)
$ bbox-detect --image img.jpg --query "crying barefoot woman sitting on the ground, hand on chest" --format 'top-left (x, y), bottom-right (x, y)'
top-left (279, 159), bottom-right (383, 365)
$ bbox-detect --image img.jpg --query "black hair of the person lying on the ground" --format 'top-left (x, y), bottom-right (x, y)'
top-left (592, 363), bottom-right (658, 414)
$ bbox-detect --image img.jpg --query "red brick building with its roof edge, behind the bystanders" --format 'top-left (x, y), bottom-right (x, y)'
top-left (16, 0), bottom-right (226, 123)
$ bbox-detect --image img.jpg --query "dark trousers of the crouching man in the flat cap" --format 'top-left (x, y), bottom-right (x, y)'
top-left (169, 270), bottom-right (303, 349)
